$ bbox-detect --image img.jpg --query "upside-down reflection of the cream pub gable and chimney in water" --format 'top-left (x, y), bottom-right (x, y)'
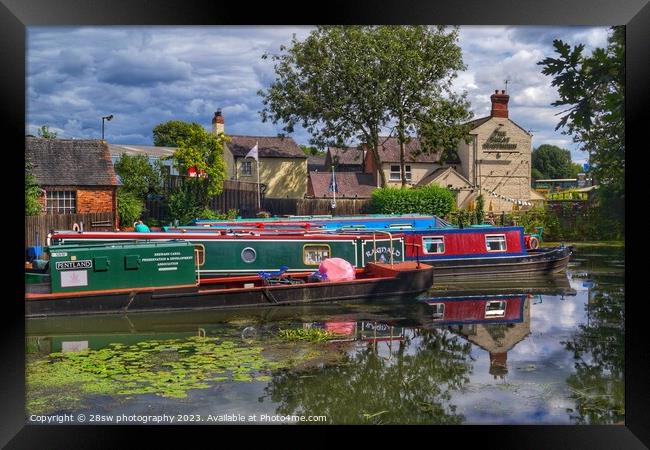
top-left (452, 298), bottom-right (530, 378)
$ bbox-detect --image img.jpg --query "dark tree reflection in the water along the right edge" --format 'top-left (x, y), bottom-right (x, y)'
top-left (563, 285), bottom-right (625, 424)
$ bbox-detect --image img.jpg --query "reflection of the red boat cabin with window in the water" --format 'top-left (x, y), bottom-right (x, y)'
top-left (423, 294), bottom-right (527, 325)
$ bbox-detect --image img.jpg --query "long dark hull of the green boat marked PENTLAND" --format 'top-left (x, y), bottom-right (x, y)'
top-left (25, 263), bottom-right (433, 317)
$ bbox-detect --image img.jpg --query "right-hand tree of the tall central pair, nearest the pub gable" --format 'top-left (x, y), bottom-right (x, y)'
top-left (377, 26), bottom-right (472, 187)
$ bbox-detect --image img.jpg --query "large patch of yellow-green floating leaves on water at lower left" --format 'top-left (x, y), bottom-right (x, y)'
top-left (26, 337), bottom-right (286, 414)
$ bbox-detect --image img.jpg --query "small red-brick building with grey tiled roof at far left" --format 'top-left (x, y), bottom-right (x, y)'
top-left (25, 136), bottom-right (118, 227)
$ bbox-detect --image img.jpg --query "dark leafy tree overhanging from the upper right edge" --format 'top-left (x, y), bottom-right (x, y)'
top-left (538, 26), bottom-right (625, 204)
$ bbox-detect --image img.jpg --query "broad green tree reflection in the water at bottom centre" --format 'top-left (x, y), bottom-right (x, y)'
top-left (260, 329), bottom-right (471, 424)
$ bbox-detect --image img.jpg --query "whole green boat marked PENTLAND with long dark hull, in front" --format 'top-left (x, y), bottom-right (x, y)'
top-left (25, 241), bottom-right (433, 317)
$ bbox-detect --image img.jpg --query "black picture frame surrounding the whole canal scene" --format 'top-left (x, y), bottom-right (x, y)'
top-left (0, 0), bottom-right (650, 449)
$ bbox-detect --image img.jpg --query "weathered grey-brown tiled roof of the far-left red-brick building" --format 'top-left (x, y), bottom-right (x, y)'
top-left (25, 137), bottom-right (117, 186)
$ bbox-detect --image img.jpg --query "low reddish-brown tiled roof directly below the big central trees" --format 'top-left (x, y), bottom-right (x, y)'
top-left (309, 172), bottom-right (377, 198)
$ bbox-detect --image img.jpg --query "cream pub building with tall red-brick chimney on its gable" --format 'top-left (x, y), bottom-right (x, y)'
top-left (362, 91), bottom-right (538, 212)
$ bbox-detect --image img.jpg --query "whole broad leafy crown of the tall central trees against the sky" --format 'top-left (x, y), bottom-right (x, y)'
top-left (259, 26), bottom-right (467, 186)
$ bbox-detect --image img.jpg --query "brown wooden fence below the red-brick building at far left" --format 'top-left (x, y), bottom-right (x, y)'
top-left (25, 212), bottom-right (115, 247)
